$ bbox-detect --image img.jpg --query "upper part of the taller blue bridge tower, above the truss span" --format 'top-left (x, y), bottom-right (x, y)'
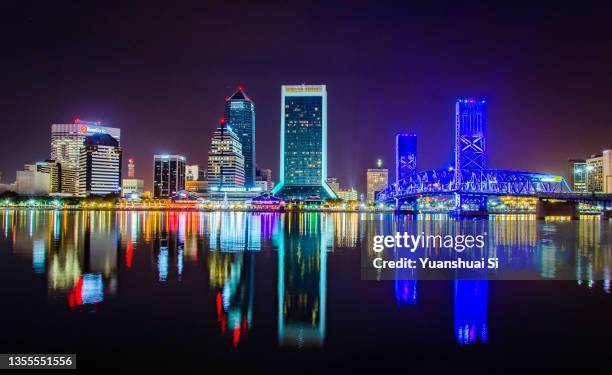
top-left (455, 99), bottom-right (487, 175)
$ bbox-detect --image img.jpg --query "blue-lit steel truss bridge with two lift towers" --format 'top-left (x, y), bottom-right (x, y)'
top-left (376, 99), bottom-right (612, 218)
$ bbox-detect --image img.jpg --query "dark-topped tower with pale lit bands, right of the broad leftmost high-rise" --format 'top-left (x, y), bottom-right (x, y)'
top-left (78, 133), bottom-right (121, 197)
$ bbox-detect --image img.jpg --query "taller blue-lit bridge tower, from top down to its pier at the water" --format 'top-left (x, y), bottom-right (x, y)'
top-left (454, 98), bottom-right (487, 215)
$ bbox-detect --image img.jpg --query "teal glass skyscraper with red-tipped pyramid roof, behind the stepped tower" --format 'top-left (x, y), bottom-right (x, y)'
top-left (223, 86), bottom-right (256, 188)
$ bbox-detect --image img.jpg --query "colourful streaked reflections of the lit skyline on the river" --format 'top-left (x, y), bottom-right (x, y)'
top-left (0, 210), bottom-right (612, 348)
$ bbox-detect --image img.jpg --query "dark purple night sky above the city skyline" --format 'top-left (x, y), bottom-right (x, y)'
top-left (0, 0), bottom-right (612, 192)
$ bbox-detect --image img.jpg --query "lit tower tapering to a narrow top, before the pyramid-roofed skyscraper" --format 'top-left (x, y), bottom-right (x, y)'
top-left (206, 119), bottom-right (244, 190)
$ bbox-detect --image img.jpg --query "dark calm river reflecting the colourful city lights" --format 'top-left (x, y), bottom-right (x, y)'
top-left (0, 210), bottom-right (612, 372)
